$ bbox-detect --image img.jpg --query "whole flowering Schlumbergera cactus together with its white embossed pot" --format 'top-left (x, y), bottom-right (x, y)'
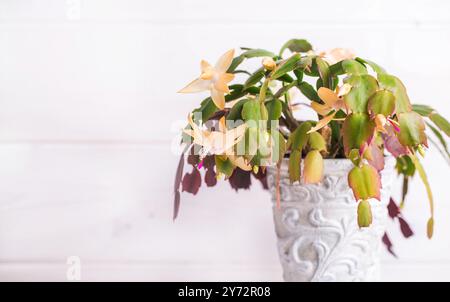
top-left (174, 39), bottom-right (450, 281)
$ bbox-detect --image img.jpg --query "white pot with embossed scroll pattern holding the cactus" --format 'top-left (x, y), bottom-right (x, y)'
top-left (267, 157), bottom-right (395, 281)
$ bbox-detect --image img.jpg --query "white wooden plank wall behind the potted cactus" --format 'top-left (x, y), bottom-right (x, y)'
top-left (0, 0), bottom-right (450, 281)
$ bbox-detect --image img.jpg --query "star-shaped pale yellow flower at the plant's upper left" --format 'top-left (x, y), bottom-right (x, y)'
top-left (178, 49), bottom-right (234, 110)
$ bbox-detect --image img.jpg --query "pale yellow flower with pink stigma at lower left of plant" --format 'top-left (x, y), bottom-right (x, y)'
top-left (184, 114), bottom-right (251, 171)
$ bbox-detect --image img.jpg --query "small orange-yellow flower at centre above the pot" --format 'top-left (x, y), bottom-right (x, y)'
top-left (308, 84), bottom-right (352, 133)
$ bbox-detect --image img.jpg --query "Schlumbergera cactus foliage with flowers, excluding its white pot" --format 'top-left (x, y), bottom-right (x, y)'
top-left (174, 39), bottom-right (450, 247)
